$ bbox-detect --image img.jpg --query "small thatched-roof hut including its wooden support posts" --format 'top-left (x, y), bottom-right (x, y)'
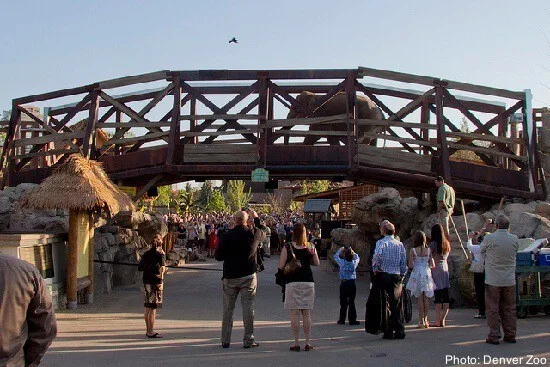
top-left (21, 154), bottom-right (135, 309)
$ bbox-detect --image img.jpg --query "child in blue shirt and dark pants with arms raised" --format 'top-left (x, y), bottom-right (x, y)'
top-left (334, 246), bottom-right (359, 325)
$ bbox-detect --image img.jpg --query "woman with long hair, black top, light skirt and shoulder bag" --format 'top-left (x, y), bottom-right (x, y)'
top-left (279, 223), bottom-right (319, 352)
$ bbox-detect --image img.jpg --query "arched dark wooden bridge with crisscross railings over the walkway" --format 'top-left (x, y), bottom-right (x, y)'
top-left (1, 67), bottom-right (546, 199)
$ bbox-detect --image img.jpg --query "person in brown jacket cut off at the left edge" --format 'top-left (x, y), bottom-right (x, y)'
top-left (0, 254), bottom-right (57, 366)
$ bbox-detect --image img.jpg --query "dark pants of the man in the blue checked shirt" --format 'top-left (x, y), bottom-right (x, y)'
top-left (379, 273), bottom-right (405, 337)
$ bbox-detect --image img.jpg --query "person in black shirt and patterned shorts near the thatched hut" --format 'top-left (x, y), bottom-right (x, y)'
top-left (138, 234), bottom-right (166, 338)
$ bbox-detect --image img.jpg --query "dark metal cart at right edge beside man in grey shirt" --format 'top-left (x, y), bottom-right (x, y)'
top-left (516, 265), bottom-right (550, 319)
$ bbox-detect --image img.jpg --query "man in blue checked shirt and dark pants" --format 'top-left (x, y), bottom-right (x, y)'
top-left (372, 221), bottom-right (407, 339)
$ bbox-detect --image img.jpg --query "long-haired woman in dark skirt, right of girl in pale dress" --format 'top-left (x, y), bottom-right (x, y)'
top-left (430, 224), bottom-right (451, 327)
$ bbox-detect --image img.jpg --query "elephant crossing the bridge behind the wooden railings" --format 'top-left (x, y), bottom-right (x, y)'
top-left (287, 91), bottom-right (384, 145)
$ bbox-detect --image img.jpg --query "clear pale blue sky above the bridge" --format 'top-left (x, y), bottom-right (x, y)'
top-left (0, 0), bottom-right (550, 109)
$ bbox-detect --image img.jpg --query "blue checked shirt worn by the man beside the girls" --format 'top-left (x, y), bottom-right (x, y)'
top-left (372, 236), bottom-right (407, 275)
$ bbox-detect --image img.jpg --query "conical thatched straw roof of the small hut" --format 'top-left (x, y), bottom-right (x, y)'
top-left (22, 154), bottom-right (135, 216)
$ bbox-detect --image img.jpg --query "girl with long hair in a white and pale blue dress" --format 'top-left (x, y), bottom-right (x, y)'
top-left (407, 231), bottom-right (435, 329)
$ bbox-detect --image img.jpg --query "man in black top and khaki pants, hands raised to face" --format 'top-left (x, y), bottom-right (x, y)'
top-left (214, 211), bottom-right (265, 348)
